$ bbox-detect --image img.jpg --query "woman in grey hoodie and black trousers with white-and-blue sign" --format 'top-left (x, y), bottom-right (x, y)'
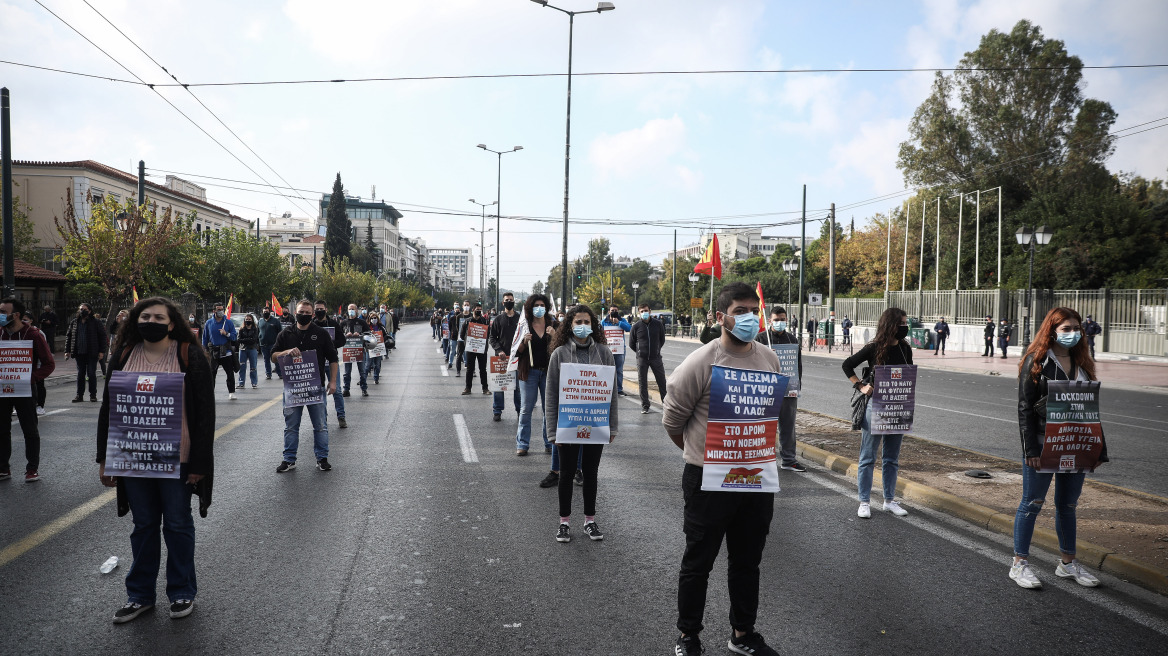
top-left (544, 305), bottom-right (618, 542)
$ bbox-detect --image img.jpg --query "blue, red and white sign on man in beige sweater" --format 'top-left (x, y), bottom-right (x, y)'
top-left (702, 365), bottom-right (787, 493)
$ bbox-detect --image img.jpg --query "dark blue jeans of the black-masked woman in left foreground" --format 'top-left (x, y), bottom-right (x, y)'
top-left (121, 466), bottom-right (197, 606)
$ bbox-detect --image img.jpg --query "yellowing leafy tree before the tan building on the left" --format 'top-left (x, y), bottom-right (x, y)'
top-left (53, 187), bottom-right (190, 302)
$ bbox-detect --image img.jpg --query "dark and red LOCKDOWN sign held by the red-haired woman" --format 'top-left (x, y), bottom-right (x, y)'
top-left (1038, 381), bottom-right (1103, 474)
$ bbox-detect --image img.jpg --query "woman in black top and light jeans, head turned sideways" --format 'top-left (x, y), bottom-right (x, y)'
top-left (843, 307), bottom-right (912, 519)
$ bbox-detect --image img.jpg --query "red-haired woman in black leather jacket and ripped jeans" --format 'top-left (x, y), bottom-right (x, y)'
top-left (1010, 307), bottom-right (1107, 588)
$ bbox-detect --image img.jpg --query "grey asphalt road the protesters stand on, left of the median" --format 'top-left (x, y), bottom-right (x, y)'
top-left (0, 326), bottom-right (1168, 655)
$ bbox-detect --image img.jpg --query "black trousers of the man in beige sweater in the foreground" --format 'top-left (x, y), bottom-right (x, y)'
top-left (677, 463), bottom-right (774, 635)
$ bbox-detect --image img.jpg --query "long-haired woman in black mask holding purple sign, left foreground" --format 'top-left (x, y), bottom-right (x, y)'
top-left (97, 298), bottom-right (215, 623)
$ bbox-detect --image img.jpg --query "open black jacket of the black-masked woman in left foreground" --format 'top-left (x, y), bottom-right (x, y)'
top-left (97, 343), bottom-right (215, 517)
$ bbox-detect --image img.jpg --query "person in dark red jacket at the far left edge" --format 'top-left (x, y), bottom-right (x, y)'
top-left (0, 298), bottom-right (57, 483)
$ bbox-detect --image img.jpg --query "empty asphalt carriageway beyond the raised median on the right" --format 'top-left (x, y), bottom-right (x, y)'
top-left (658, 340), bottom-right (1168, 497)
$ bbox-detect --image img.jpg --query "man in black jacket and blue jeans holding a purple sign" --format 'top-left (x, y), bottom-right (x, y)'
top-left (271, 299), bottom-right (334, 474)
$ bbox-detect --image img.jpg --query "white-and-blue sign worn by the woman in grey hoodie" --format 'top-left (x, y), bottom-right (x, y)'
top-left (556, 362), bottom-right (617, 445)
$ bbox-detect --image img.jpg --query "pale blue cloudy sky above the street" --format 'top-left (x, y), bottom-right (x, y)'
top-left (0, 0), bottom-right (1168, 289)
